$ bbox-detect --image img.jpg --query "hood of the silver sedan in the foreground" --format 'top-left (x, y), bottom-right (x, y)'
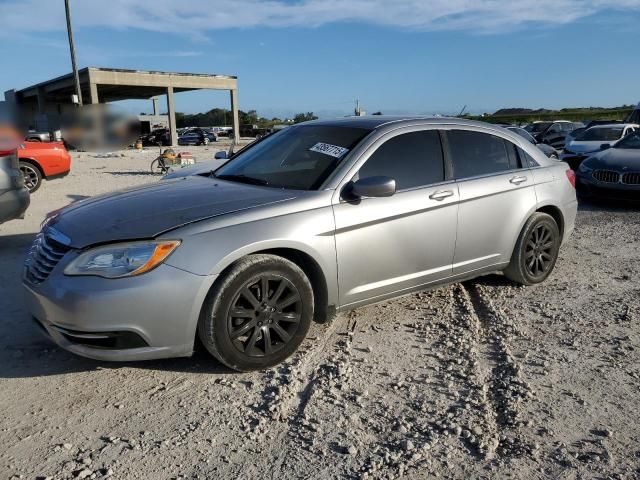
top-left (48, 176), bottom-right (300, 248)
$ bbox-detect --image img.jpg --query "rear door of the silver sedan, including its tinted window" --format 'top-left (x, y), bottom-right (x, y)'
top-left (446, 128), bottom-right (536, 275)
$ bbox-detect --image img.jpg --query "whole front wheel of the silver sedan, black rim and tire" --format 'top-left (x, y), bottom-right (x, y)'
top-left (198, 254), bottom-right (314, 371)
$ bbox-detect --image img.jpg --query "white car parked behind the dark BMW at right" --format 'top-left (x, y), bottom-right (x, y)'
top-left (560, 123), bottom-right (640, 170)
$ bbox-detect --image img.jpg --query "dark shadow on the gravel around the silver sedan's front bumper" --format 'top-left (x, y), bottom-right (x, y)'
top-left (0, 230), bottom-right (237, 379)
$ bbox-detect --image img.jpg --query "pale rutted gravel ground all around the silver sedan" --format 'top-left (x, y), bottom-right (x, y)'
top-left (0, 145), bottom-right (640, 479)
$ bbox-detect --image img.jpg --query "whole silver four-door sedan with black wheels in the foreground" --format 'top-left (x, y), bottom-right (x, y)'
top-left (24, 116), bottom-right (577, 371)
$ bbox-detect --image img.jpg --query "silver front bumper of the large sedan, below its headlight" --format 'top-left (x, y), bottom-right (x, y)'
top-left (24, 261), bottom-right (216, 361)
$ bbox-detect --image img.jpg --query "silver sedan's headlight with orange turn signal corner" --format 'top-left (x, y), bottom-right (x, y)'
top-left (64, 240), bottom-right (180, 278)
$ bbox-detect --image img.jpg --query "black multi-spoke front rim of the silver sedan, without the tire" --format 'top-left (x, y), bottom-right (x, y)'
top-left (227, 274), bottom-right (302, 357)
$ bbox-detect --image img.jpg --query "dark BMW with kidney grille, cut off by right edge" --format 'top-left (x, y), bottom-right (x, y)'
top-left (576, 132), bottom-right (640, 200)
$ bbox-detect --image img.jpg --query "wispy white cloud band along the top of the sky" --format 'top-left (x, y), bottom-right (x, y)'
top-left (0, 0), bottom-right (640, 37)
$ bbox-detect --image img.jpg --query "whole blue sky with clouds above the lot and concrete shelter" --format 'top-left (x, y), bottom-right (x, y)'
top-left (0, 0), bottom-right (640, 117)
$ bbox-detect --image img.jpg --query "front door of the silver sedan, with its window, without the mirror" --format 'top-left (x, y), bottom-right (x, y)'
top-left (333, 130), bottom-right (458, 306)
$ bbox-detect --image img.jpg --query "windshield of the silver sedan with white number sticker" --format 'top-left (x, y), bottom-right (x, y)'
top-left (215, 125), bottom-right (371, 190)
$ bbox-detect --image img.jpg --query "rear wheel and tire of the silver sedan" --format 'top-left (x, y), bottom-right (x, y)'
top-left (504, 212), bottom-right (561, 285)
